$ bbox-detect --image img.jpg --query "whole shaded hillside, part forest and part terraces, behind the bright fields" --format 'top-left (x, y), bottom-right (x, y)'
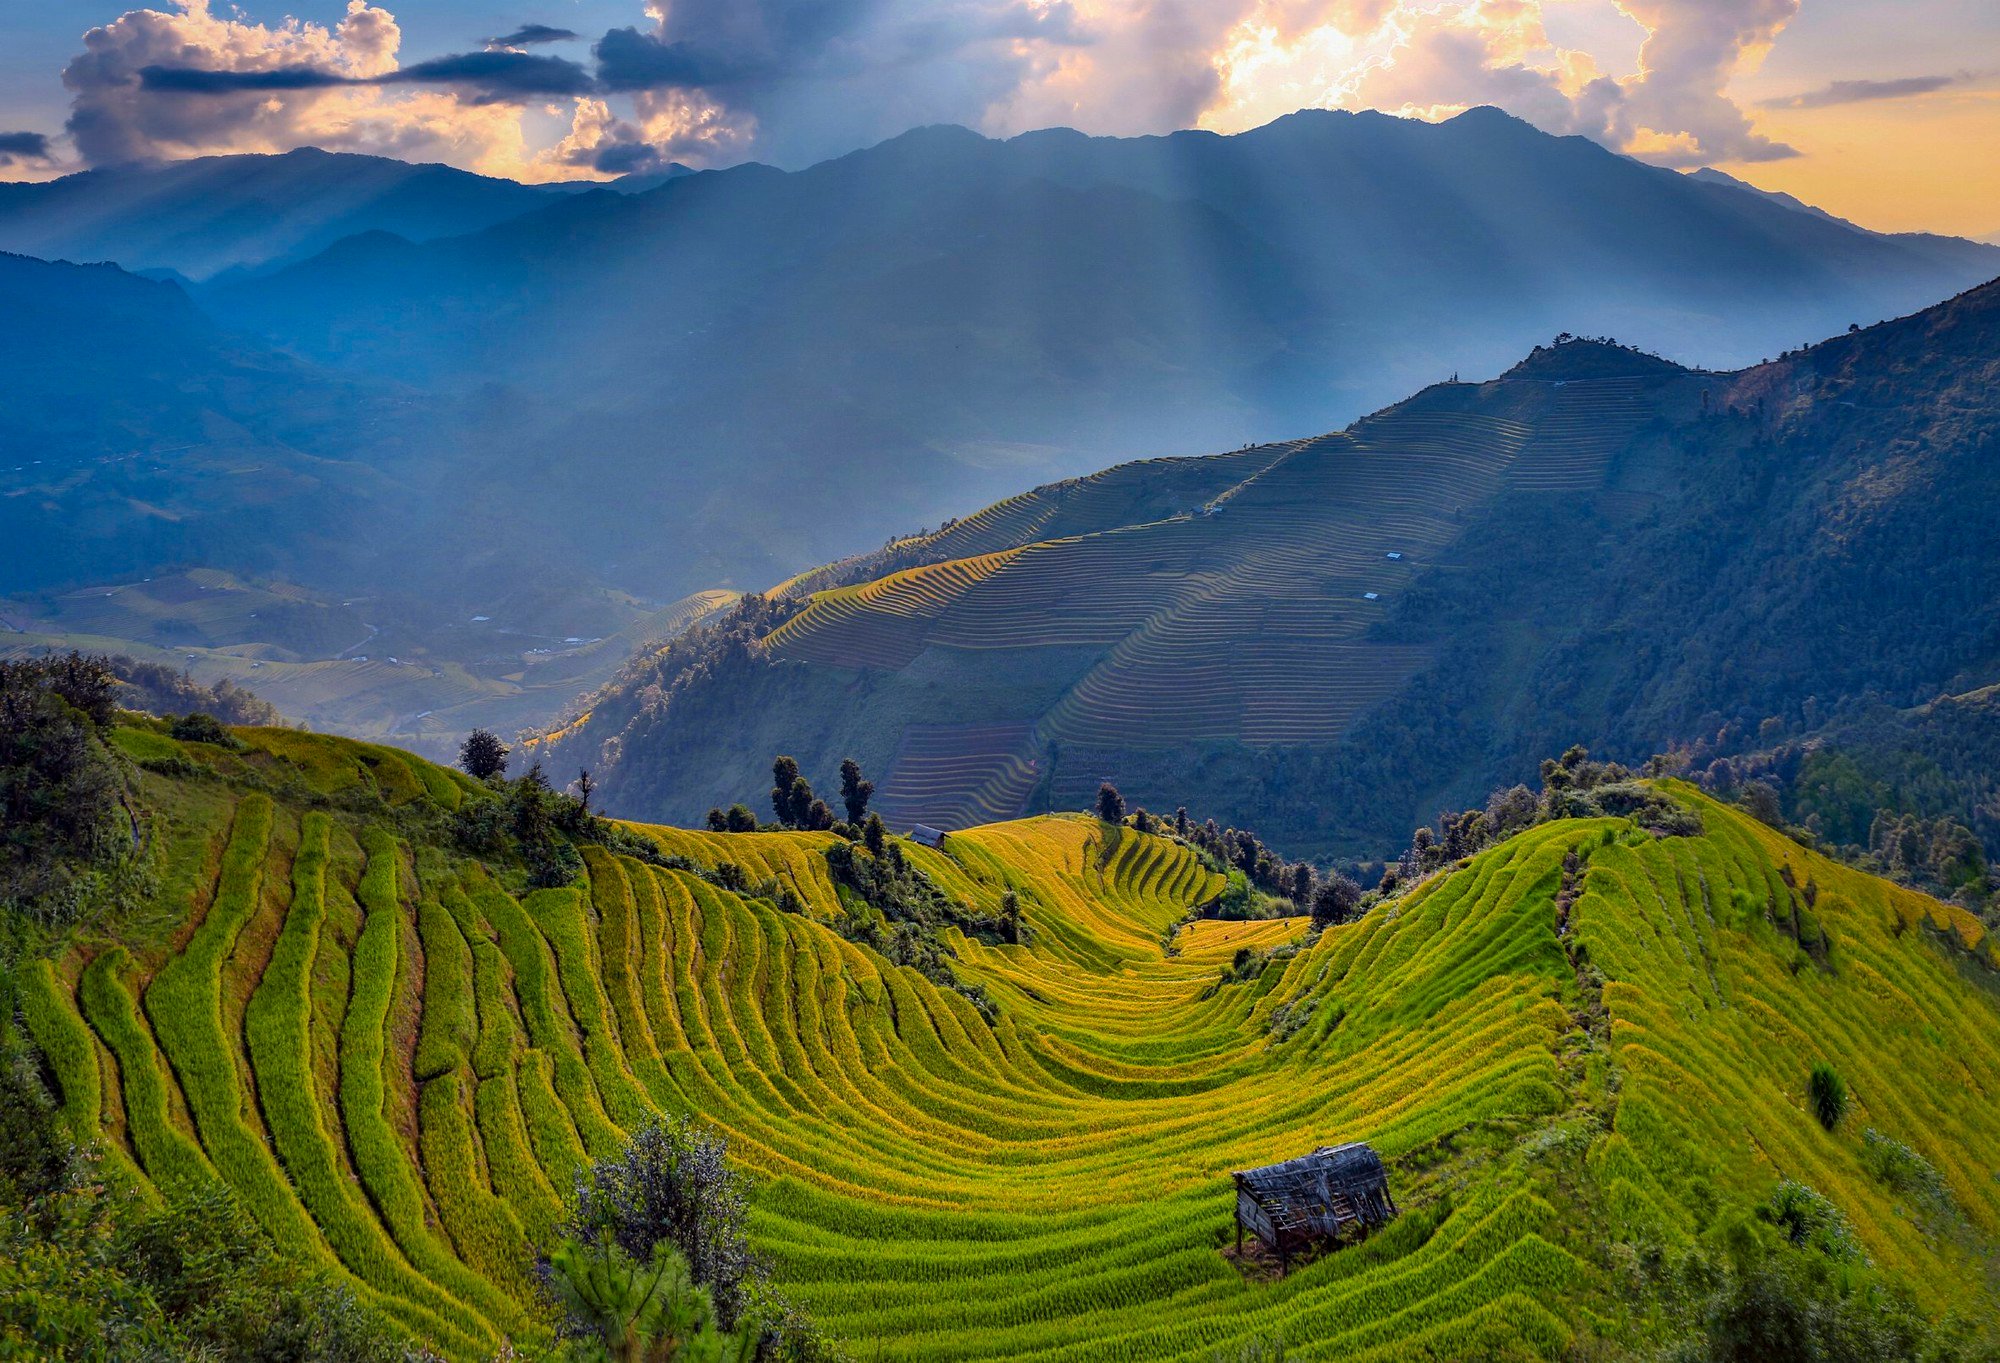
top-left (550, 273), bottom-right (2000, 857)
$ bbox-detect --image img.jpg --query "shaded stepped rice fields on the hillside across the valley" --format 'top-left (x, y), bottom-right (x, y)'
top-left (770, 378), bottom-right (1688, 825)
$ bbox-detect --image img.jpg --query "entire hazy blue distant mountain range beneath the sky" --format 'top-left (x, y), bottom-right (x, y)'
top-left (0, 110), bottom-right (2000, 779)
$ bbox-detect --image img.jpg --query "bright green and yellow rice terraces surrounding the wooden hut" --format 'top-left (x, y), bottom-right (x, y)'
top-left (24, 715), bottom-right (2000, 1361)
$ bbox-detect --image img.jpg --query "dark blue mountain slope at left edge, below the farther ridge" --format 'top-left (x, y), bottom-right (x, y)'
top-left (0, 256), bottom-right (410, 592)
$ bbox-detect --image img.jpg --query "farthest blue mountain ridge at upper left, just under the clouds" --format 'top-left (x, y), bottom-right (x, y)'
top-left (0, 148), bottom-right (576, 278)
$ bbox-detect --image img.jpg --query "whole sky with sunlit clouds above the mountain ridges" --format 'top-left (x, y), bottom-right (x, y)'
top-left (0, 0), bottom-right (2000, 236)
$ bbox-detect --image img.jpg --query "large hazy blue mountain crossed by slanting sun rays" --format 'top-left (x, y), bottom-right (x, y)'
top-left (191, 110), bottom-right (2000, 607)
